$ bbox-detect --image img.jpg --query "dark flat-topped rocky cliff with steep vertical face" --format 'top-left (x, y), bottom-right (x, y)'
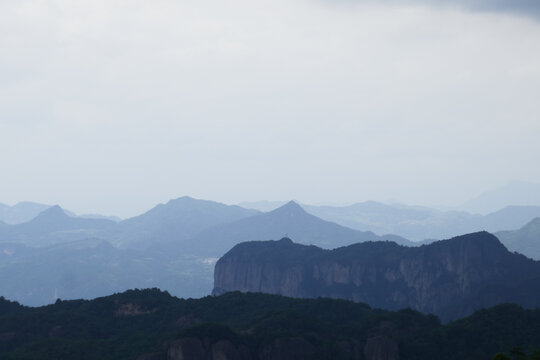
top-left (214, 232), bottom-right (540, 321)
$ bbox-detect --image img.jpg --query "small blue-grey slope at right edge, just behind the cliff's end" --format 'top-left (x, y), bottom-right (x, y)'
top-left (495, 218), bottom-right (540, 260)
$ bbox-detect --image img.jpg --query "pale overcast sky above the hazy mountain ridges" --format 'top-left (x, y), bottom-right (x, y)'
top-left (0, 0), bottom-right (540, 217)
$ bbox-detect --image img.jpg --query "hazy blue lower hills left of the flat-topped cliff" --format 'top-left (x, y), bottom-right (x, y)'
top-left (0, 239), bottom-right (214, 306)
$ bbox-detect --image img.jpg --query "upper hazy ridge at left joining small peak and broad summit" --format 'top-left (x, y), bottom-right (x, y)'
top-left (0, 197), bottom-right (259, 248)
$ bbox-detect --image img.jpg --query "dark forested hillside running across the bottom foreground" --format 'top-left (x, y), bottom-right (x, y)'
top-left (0, 289), bottom-right (540, 360)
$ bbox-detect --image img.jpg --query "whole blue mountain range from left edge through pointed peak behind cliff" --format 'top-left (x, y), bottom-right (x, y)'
top-left (0, 197), bottom-right (407, 305)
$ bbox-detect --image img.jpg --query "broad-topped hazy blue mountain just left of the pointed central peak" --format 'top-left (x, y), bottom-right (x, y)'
top-left (113, 196), bottom-right (259, 248)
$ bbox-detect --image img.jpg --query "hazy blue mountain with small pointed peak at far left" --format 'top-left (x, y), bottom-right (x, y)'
top-left (0, 206), bottom-right (116, 246)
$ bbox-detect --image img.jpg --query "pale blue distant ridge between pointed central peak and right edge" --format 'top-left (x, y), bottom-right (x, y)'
top-left (303, 201), bottom-right (540, 241)
